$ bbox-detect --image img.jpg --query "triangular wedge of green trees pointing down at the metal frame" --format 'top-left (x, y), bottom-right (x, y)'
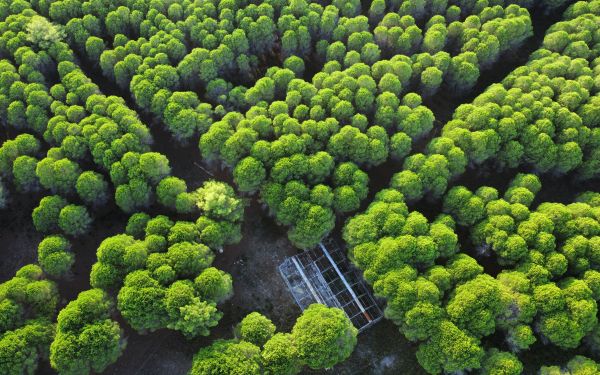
top-left (23, 0), bottom-right (576, 248)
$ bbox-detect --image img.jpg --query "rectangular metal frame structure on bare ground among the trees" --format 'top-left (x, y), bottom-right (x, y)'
top-left (279, 239), bottom-right (383, 332)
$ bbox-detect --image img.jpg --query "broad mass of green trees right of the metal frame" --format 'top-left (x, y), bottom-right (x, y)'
top-left (344, 1), bottom-right (600, 374)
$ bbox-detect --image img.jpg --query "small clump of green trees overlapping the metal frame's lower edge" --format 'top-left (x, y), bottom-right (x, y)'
top-left (190, 304), bottom-right (357, 375)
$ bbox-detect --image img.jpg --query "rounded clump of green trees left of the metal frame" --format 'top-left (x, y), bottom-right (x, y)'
top-left (90, 213), bottom-right (233, 338)
